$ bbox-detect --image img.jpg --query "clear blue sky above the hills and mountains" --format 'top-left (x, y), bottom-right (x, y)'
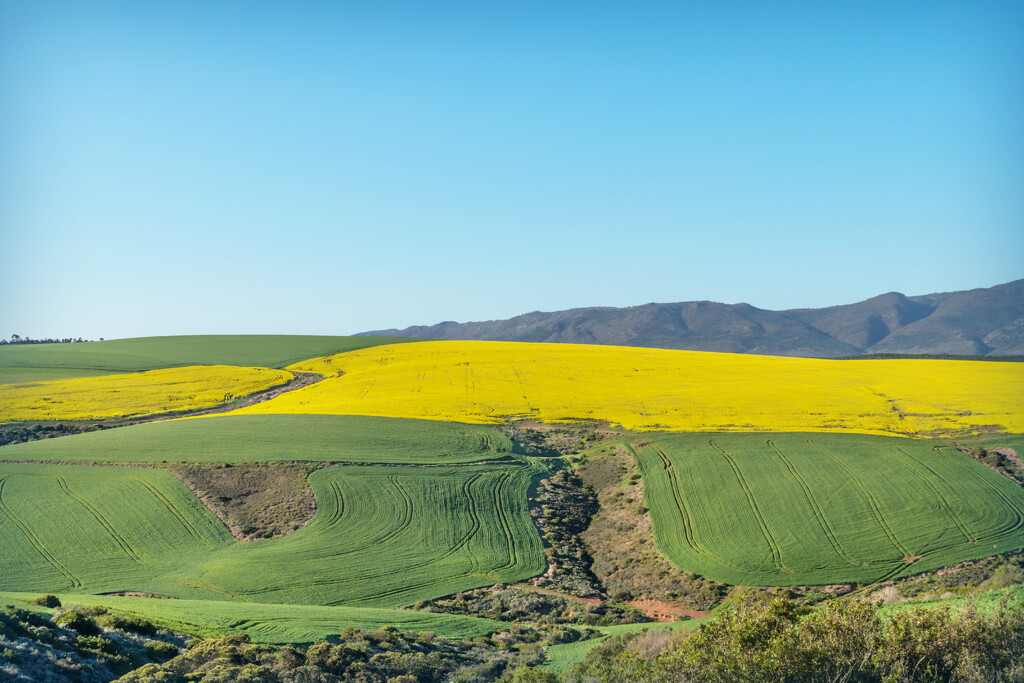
top-left (0, 0), bottom-right (1024, 339)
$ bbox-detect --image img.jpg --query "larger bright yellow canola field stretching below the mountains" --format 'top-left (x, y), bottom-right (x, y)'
top-left (238, 341), bottom-right (1024, 435)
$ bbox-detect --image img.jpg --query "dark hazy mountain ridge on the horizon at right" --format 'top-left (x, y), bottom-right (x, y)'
top-left (360, 280), bottom-right (1024, 358)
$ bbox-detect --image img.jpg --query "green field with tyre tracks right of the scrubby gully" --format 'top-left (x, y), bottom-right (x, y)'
top-left (635, 433), bottom-right (1024, 586)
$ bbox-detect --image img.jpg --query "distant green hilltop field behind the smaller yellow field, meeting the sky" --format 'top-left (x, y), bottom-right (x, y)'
top-left (0, 335), bottom-right (418, 384)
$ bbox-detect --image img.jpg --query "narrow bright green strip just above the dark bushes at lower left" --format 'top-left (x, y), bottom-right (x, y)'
top-left (0, 593), bottom-right (504, 644)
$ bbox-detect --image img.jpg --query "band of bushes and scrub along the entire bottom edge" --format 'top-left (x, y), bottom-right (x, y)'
top-left (0, 593), bottom-right (1024, 683)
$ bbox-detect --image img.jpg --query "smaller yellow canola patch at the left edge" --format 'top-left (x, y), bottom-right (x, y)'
top-left (0, 366), bottom-right (295, 423)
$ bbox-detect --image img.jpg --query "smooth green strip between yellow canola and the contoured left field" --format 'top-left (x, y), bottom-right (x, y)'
top-left (0, 415), bottom-right (513, 465)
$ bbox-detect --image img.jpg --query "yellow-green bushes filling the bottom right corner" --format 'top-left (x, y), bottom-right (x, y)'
top-left (564, 594), bottom-right (1024, 683)
